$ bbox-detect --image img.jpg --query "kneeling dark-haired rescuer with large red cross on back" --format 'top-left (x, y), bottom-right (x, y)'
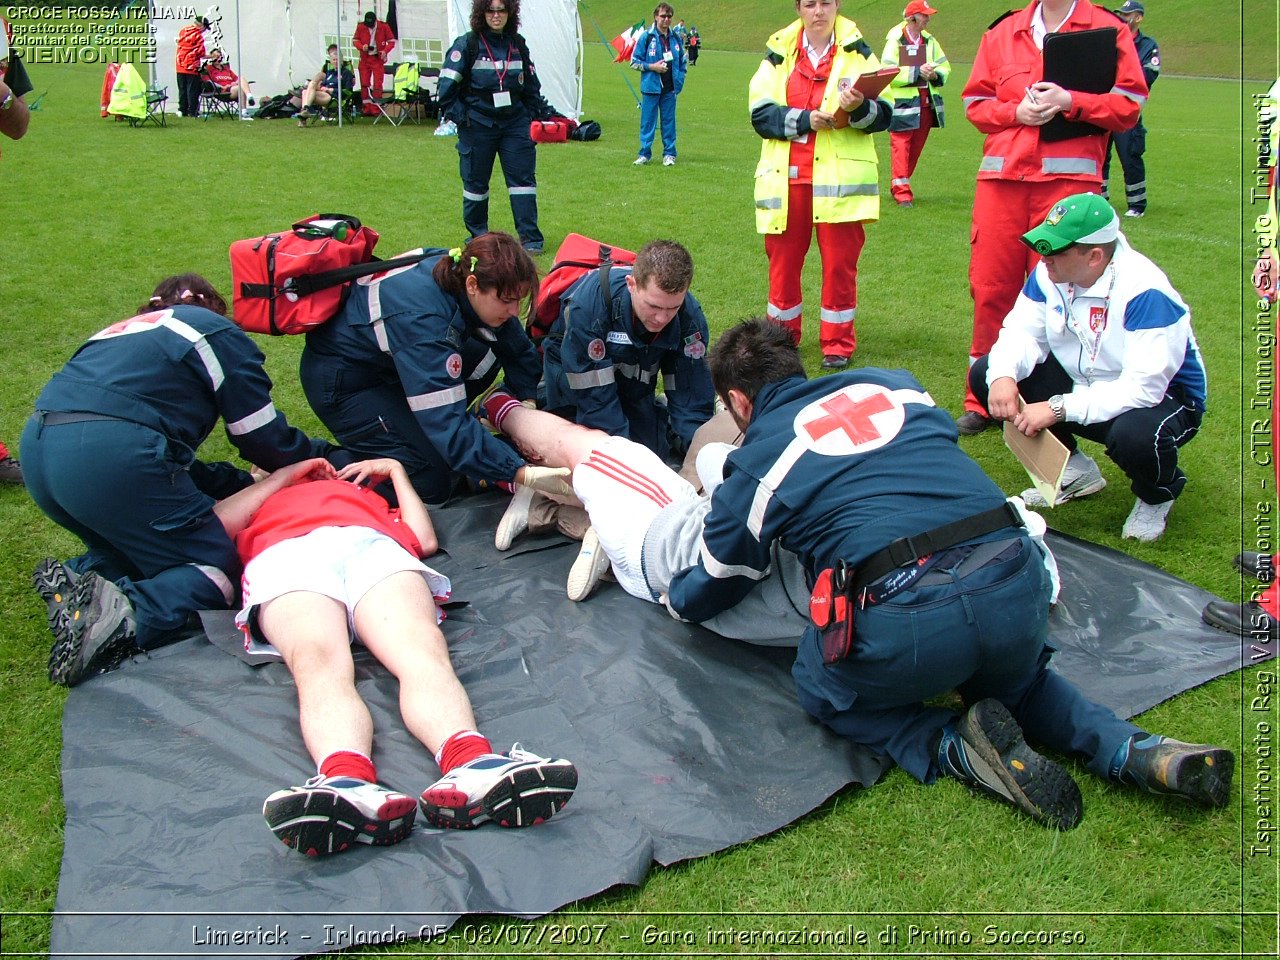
top-left (667, 320), bottom-right (1234, 829)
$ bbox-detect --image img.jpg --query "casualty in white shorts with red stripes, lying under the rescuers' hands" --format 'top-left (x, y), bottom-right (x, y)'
top-left (473, 390), bottom-right (809, 646)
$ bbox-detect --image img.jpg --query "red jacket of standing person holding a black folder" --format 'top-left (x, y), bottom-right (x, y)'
top-left (963, 0), bottom-right (1147, 183)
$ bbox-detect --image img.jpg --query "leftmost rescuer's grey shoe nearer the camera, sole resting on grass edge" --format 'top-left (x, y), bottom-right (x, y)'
top-left (49, 573), bottom-right (137, 686)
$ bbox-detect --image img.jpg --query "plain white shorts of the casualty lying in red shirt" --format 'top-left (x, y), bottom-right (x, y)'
top-left (236, 526), bottom-right (452, 653)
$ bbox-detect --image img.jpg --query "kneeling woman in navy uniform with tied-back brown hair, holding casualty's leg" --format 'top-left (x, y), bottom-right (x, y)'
top-left (301, 233), bottom-right (541, 503)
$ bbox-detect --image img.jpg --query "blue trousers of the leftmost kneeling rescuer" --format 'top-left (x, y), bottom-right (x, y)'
top-left (22, 413), bottom-right (241, 648)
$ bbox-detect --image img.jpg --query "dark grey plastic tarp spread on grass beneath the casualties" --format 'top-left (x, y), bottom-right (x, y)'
top-left (51, 497), bottom-right (1274, 956)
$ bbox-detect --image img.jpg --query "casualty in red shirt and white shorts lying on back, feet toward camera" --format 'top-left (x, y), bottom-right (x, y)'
top-left (216, 460), bottom-right (577, 856)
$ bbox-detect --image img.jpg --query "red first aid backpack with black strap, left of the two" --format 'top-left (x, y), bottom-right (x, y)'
top-left (230, 214), bottom-right (428, 337)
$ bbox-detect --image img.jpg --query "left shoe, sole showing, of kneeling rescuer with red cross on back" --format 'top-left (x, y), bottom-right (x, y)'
top-left (938, 699), bottom-right (1084, 829)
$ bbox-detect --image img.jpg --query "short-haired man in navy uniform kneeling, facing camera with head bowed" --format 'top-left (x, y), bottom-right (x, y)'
top-left (543, 241), bottom-right (716, 458)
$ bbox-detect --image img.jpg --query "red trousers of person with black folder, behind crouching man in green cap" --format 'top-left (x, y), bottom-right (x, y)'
top-left (964, 179), bottom-right (1100, 416)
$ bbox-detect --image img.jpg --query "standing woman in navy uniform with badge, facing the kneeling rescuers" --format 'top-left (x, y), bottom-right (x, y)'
top-left (436, 0), bottom-right (556, 255)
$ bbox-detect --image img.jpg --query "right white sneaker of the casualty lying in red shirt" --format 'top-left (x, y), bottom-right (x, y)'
top-left (419, 744), bottom-right (577, 829)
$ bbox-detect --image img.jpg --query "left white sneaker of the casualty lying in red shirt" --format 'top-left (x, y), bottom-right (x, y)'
top-left (262, 777), bottom-right (417, 856)
